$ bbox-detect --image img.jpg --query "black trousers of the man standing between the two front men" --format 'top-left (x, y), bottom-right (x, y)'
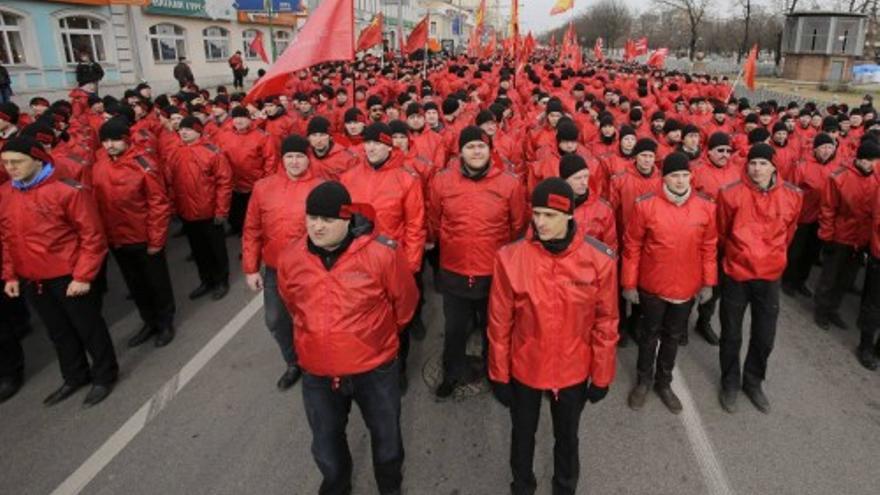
top-left (443, 293), bottom-right (489, 380)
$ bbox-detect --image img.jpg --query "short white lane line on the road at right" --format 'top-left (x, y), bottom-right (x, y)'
top-left (672, 367), bottom-right (734, 495)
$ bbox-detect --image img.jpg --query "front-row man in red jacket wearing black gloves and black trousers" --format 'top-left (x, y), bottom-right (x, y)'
top-left (489, 178), bottom-right (617, 495)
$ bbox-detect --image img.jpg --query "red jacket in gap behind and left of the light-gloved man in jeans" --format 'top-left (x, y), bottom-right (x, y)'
top-left (214, 127), bottom-right (278, 192)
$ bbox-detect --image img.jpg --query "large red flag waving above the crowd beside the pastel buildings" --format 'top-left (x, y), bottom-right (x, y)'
top-left (245, 0), bottom-right (354, 102)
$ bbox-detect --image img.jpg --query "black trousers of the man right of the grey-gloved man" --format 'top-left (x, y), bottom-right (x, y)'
top-left (719, 275), bottom-right (780, 390)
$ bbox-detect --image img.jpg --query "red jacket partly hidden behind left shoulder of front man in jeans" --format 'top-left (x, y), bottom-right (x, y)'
top-left (241, 170), bottom-right (323, 273)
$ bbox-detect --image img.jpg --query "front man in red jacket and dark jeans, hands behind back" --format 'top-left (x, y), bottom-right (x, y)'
top-left (278, 182), bottom-right (418, 494)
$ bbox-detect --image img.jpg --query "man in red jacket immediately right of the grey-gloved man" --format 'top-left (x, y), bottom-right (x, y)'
top-left (718, 143), bottom-right (803, 413)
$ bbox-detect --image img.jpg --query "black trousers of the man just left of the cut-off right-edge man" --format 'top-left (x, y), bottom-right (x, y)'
top-left (814, 242), bottom-right (862, 316)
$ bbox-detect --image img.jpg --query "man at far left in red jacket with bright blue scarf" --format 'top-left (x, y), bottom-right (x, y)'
top-left (0, 136), bottom-right (119, 407)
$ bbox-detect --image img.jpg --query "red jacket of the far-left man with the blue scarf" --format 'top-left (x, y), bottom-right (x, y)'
top-left (0, 174), bottom-right (107, 282)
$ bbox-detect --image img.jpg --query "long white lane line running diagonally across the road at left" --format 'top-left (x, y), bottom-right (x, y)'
top-left (52, 295), bottom-right (263, 495)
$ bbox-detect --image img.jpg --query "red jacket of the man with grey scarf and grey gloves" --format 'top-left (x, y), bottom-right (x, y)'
top-left (620, 191), bottom-right (718, 301)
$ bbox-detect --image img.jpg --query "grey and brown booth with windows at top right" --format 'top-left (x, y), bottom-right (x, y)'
top-left (782, 12), bottom-right (868, 84)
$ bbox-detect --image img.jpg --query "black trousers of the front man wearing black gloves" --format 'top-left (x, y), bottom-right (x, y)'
top-left (510, 379), bottom-right (587, 495)
